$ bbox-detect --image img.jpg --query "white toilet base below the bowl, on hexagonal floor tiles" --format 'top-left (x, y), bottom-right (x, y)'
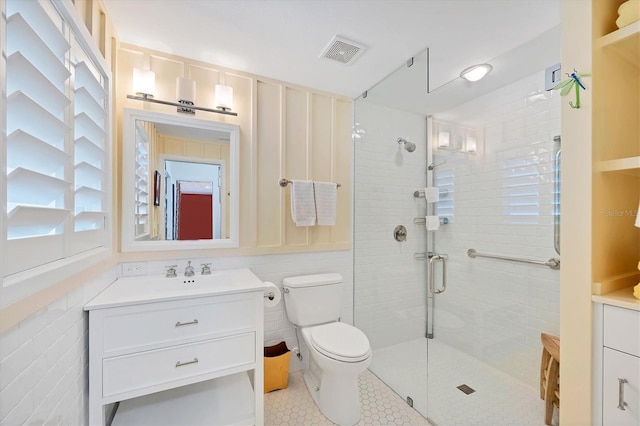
top-left (303, 359), bottom-right (360, 426)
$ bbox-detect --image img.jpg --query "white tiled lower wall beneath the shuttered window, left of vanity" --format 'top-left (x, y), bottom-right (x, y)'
top-left (0, 268), bottom-right (116, 425)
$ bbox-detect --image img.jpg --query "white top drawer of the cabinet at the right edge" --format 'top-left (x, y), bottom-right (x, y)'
top-left (604, 305), bottom-right (640, 357)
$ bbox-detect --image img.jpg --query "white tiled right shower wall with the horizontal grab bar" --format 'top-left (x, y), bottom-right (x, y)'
top-left (434, 72), bottom-right (566, 386)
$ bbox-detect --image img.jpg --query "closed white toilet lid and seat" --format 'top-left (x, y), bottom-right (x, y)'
top-left (311, 322), bottom-right (370, 362)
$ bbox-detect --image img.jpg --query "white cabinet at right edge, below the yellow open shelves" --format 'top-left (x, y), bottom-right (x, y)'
top-left (594, 296), bottom-right (640, 426)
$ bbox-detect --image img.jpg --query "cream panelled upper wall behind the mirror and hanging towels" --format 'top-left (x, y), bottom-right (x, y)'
top-left (114, 44), bottom-right (352, 260)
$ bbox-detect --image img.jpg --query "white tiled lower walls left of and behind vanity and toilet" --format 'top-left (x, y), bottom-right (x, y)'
top-left (0, 251), bottom-right (353, 425)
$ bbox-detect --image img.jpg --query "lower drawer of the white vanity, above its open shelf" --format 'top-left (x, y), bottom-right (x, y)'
top-left (102, 333), bottom-right (256, 398)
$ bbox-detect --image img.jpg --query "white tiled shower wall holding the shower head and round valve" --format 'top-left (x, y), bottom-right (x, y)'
top-left (354, 101), bottom-right (427, 349)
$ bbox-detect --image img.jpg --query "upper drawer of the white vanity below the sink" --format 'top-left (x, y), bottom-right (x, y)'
top-left (103, 297), bottom-right (256, 355)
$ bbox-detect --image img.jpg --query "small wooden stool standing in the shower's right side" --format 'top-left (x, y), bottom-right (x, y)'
top-left (540, 333), bottom-right (560, 425)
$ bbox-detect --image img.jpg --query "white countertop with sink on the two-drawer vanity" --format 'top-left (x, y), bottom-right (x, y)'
top-left (84, 269), bottom-right (266, 311)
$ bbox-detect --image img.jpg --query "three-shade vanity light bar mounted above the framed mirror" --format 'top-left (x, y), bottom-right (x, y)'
top-left (127, 68), bottom-right (238, 116)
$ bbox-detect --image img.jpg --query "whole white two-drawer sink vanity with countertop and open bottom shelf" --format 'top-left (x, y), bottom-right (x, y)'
top-left (85, 269), bottom-right (264, 425)
